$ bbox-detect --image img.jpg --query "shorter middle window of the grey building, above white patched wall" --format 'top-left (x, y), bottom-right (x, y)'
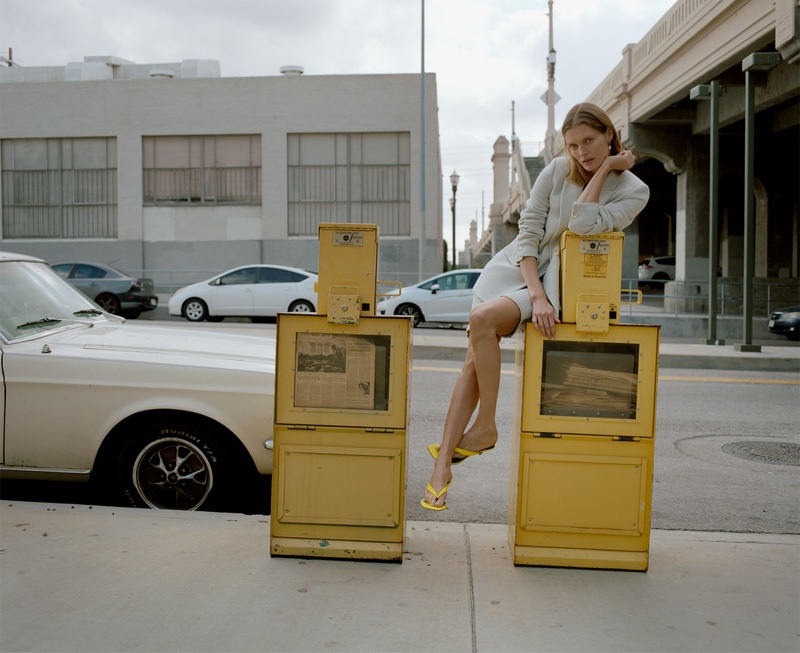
top-left (142, 135), bottom-right (261, 206)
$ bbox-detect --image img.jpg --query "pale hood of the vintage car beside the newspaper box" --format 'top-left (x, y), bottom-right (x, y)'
top-left (25, 323), bottom-right (275, 374)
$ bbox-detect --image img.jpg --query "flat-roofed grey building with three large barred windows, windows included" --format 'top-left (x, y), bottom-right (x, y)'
top-left (0, 57), bottom-right (442, 290)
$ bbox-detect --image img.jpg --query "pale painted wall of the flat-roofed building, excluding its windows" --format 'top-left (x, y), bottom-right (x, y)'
top-left (0, 58), bottom-right (442, 283)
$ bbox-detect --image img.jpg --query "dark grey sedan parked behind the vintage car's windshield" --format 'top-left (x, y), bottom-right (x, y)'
top-left (52, 263), bottom-right (158, 318)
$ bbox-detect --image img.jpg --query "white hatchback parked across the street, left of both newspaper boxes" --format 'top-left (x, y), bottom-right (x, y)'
top-left (169, 265), bottom-right (317, 322)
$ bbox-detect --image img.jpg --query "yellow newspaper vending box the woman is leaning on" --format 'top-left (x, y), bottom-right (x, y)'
top-left (509, 233), bottom-right (659, 571)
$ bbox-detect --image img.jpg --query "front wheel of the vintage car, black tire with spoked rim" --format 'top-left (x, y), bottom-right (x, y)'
top-left (105, 418), bottom-right (242, 510)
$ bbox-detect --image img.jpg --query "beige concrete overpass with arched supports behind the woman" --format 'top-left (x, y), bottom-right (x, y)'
top-left (472, 0), bottom-right (800, 319)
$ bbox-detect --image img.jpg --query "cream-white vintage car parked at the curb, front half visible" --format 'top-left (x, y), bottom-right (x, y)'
top-left (0, 252), bottom-right (275, 510)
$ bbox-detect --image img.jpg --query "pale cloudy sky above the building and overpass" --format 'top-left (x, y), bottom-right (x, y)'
top-left (0, 0), bottom-right (675, 251)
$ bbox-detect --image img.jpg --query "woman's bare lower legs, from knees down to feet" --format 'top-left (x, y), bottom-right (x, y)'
top-left (425, 297), bottom-right (519, 505)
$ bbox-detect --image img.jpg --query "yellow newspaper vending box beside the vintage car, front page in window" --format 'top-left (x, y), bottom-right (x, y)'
top-left (270, 224), bottom-right (412, 562)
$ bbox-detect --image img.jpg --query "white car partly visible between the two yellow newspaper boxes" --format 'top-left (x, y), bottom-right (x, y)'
top-left (378, 270), bottom-right (481, 326)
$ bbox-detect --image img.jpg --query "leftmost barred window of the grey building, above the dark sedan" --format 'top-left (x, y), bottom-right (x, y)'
top-left (0, 138), bottom-right (117, 238)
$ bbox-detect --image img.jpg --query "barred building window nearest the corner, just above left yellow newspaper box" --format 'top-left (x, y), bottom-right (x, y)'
top-left (287, 132), bottom-right (411, 236)
